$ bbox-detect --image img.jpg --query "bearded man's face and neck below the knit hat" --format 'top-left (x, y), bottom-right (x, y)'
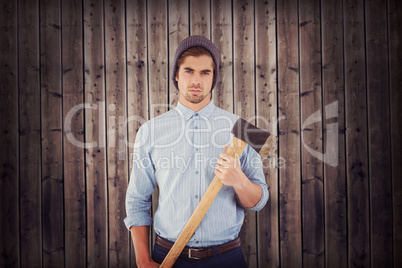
top-left (175, 55), bottom-right (214, 110)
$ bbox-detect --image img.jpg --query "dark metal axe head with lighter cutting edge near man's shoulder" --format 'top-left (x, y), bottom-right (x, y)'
top-left (232, 118), bottom-right (277, 158)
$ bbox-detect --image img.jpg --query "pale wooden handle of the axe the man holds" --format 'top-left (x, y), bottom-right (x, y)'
top-left (160, 137), bottom-right (247, 268)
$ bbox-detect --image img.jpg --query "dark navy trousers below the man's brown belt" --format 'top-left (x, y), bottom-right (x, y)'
top-left (152, 245), bottom-right (247, 268)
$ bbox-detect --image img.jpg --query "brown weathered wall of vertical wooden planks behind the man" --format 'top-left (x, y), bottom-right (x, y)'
top-left (0, 0), bottom-right (402, 267)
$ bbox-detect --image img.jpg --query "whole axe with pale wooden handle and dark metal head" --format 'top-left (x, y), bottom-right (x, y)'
top-left (160, 118), bottom-right (277, 268)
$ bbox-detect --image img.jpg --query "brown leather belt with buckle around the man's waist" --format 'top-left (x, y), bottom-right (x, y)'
top-left (155, 235), bottom-right (241, 260)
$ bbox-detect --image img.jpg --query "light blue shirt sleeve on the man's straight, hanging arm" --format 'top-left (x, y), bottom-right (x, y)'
top-left (124, 125), bottom-right (155, 229)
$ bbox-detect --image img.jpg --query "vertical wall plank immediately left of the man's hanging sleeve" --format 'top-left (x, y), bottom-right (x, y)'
top-left (105, 0), bottom-right (129, 267)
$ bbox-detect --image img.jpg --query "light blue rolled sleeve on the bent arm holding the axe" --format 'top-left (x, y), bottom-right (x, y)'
top-left (241, 145), bottom-right (269, 211)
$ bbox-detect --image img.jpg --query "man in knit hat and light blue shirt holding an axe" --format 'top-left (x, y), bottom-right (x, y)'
top-left (125, 36), bottom-right (268, 267)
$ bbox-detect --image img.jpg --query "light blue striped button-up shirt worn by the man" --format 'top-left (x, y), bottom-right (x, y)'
top-left (124, 101), bottom-right (269, 247)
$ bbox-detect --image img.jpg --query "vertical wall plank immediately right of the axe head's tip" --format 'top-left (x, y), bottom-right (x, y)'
top-left (277, 0), bottom-right (302, 267)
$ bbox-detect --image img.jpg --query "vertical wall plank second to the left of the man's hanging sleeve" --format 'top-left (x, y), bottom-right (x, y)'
top-left (84, 0), bottom-right (109, 267)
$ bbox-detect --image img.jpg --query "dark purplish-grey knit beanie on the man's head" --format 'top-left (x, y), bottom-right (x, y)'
top-left (172, 35), bottom-right (220, 90)
